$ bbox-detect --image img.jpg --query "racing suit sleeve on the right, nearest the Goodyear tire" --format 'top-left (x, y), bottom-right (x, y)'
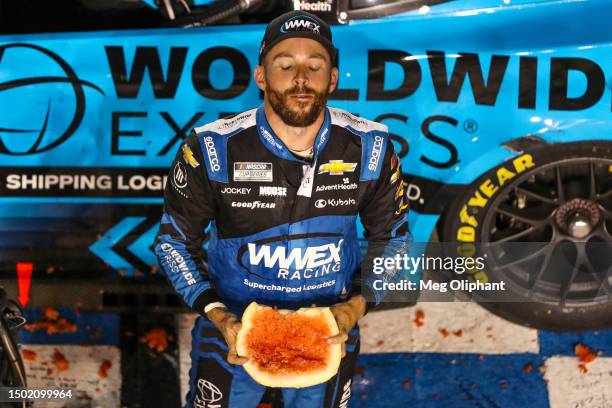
top-left (352, 139), bottom-right (412, 313)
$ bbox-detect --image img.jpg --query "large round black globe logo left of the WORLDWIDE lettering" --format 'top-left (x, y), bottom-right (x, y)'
top-left (0, 43), bottom-right (104, 156)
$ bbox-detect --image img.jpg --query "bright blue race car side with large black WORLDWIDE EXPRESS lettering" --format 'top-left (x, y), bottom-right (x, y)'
top-left (0, 1), bottom-right (612, 278)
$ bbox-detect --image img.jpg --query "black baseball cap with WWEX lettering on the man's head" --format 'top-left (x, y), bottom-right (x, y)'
top-left (259, 11), bottom-right (338, 67)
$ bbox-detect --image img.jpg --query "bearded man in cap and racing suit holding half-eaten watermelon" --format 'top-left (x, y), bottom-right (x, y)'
top-left (156, 12), bottom-right (409, 408)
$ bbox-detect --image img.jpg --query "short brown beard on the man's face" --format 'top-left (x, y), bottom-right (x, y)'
top-left (266, 86), bottom-right (329, 127)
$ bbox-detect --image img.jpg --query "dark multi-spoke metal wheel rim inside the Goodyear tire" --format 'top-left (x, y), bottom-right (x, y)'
top-left (481, 158), bottom-right (612, 306)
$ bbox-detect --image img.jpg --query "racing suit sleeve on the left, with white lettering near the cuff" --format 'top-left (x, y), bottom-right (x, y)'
top-left (155, 131), bottom-right (221, 314)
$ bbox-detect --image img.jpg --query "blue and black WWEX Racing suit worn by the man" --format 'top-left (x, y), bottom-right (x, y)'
top-left (155, 107), bottom-right (410, 408)
